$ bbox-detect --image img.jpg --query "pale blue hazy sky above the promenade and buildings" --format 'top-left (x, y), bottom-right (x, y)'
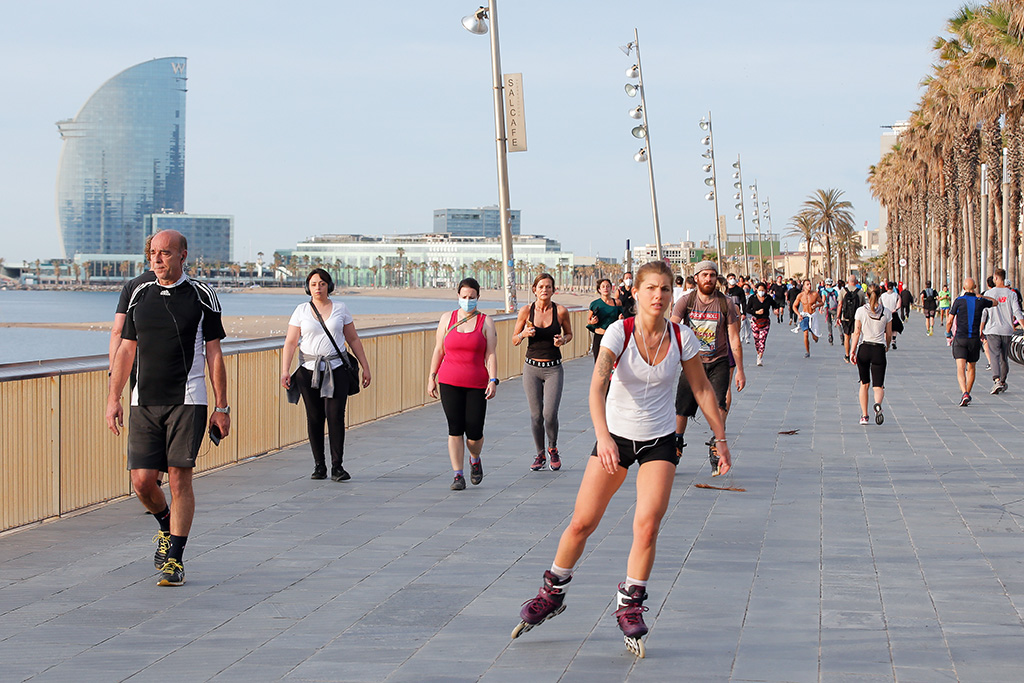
top-left (0, 0), bottom-right (962, 262)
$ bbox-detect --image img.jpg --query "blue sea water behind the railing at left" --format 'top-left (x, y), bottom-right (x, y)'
top-left (0, 290), bottom-right (455, 364)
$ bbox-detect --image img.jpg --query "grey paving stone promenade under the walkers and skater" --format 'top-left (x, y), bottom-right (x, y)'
top-left (0, 315), bottom-right (1024, 683)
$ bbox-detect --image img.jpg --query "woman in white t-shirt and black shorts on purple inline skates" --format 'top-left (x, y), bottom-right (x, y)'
top-left (512, 261), bottom-right (730, 656)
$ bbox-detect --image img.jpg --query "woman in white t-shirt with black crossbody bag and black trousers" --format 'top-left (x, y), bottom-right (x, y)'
top-left (281, 268), bottom-right (370, 481)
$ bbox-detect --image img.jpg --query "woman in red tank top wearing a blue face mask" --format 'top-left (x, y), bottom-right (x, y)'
top-left (427, 278), bottom-right (498, 490)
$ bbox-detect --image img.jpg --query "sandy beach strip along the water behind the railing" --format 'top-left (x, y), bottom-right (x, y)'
top-left (0, 287), bottom-right (597, 339)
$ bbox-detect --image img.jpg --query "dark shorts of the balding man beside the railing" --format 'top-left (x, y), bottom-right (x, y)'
top-left (128, 405), bottom-right (206, 472)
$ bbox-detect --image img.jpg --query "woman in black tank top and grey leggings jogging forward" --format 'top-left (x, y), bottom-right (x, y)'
top-left (512, 272), bottom-right (572, 472)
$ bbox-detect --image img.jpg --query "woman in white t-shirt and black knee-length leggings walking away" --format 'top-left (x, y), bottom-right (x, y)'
top-left (850, 285), bottom-right (893, 425)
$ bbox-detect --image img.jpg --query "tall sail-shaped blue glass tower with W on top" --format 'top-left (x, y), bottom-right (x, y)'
top-left (56, 57), bottom-right (186, 258)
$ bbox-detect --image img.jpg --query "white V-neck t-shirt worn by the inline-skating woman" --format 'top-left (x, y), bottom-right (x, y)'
top-left (601, 321), bottom-right (700, 441)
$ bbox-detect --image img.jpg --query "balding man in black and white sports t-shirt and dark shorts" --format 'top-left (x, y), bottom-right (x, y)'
top-left (106, 230), bottom-right (230, 586)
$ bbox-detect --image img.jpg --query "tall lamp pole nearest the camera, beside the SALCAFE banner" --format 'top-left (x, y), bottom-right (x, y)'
top-left (462, 0), bottom-right (517, 313)
